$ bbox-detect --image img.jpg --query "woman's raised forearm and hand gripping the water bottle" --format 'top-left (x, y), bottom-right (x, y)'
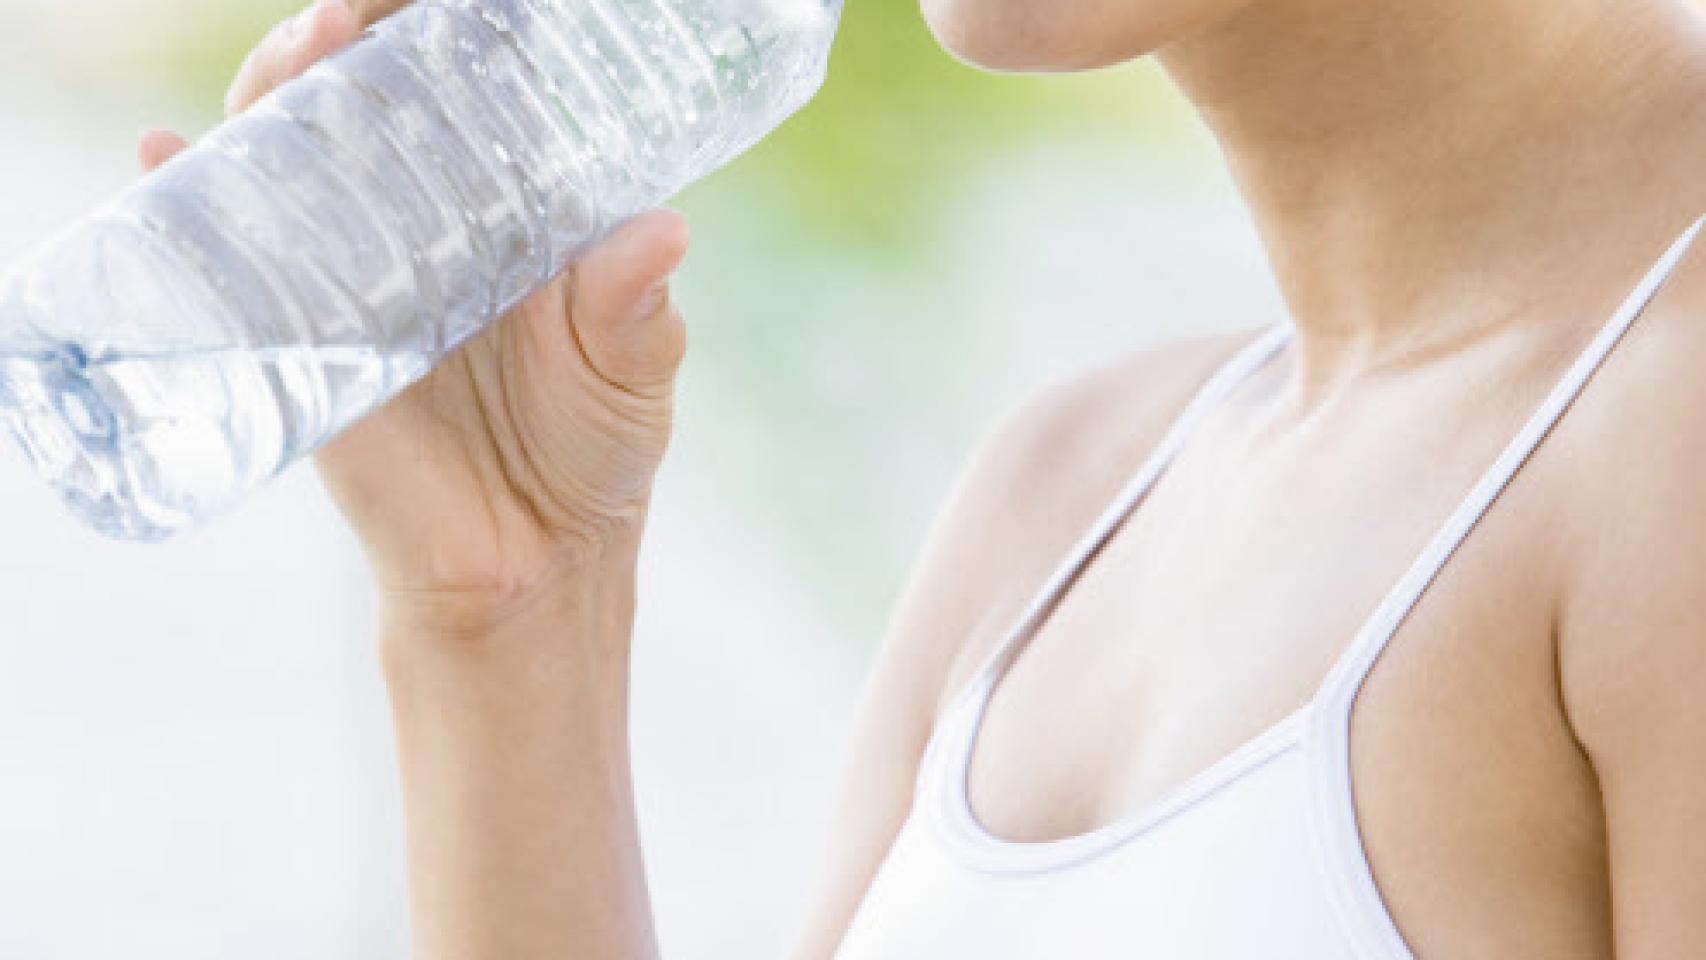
top-left (140, 2), bottom-right (686, 960)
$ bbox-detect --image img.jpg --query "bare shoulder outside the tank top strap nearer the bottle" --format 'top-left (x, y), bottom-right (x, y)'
top-left (894, 331), bottom-right (1257, 716)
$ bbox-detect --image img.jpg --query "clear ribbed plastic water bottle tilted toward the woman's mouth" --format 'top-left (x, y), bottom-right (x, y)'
top-left (0, 0), bottom-right (841, 539)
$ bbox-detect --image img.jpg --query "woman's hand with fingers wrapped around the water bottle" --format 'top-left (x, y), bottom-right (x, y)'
top-left (140, 0), bottom-right (688, 633)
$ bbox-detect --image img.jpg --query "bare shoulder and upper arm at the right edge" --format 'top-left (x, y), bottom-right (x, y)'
top-left (1556, 269), bottom-right (1706, 960)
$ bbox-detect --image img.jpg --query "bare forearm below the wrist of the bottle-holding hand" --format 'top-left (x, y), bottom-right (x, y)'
top-left (382, 532), bottom-right (657, 960)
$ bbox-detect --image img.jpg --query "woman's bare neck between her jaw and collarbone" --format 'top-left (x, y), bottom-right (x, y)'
top-left (1162, 0), bottom-right (1706, 406)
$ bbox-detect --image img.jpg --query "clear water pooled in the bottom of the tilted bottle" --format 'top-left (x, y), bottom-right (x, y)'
top-left (0, 343), bottom-right (430, 541)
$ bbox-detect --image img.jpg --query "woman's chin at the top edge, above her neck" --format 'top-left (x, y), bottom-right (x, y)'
top-left (921, 0), bottom-right (1254, 73)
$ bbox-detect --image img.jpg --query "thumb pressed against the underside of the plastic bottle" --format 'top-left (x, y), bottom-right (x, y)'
top-left (568, 210), bottom-right (688, 397)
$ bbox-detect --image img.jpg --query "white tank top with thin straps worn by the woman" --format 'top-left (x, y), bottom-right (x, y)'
top-left (838, 218), bottom-right (1706, 960)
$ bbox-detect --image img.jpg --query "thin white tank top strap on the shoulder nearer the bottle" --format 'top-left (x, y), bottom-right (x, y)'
top-left (943, 322), bottom-right (1295, 720)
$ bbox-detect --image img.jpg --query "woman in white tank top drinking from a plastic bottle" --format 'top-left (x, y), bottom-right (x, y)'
top-left (143, 0), bottom-right (1706, 960)
